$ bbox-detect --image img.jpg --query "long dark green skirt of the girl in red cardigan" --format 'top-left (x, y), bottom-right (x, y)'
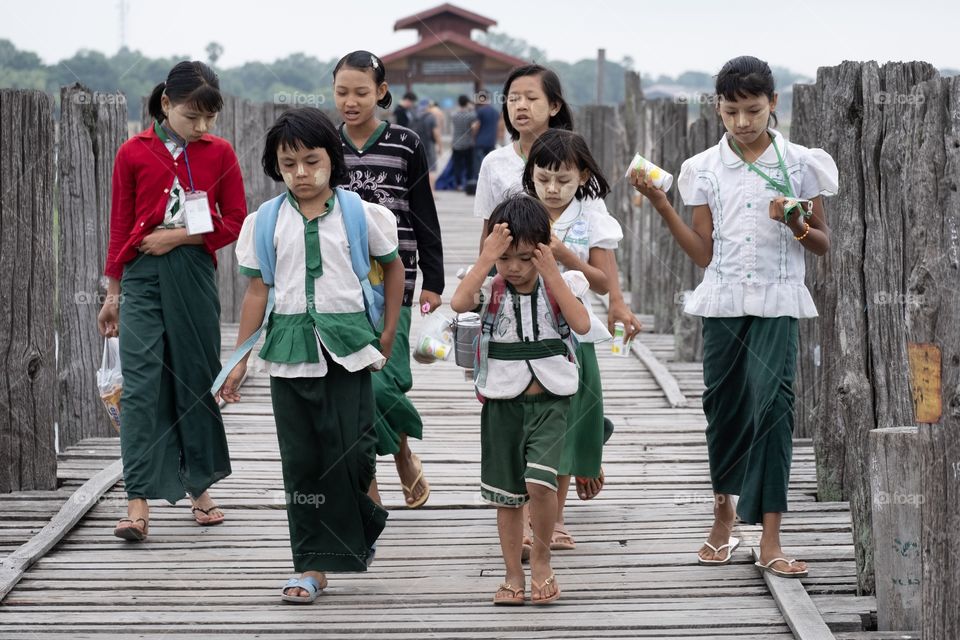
top-left (120, 246), bottom-right (231, 503)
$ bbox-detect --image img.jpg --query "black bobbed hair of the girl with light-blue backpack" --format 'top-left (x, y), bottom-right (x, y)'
top-left (260, 107), bottom-right (347, 188)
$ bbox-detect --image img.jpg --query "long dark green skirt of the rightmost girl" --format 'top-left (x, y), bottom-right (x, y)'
top-left (703, 316), bottom-right (799, 524)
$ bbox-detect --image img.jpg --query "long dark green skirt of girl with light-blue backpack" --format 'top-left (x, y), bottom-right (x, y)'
top-left (270, 368), bottom-right (387, 572)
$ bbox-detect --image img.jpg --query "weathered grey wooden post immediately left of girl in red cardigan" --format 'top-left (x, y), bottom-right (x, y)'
top-left (57, 84), bottom-right (127, 449)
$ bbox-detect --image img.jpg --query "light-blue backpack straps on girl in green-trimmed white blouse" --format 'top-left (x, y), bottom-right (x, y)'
top-left (211, 187), bottom-right (384, 393)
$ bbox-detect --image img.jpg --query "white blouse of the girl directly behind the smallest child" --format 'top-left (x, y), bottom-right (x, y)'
top-left (552, 198), bottom-right (623, 342)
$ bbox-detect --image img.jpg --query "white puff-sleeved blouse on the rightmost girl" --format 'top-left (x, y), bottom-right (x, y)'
top-left (677, 129), bottom-right (838, 318)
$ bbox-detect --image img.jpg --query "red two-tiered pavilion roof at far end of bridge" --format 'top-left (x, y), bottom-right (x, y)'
top-left (382, 3), bottom-right (527, 91)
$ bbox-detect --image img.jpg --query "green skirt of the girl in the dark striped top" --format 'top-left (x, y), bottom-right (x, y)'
top-left (372, 307), bottom-right (423, 456)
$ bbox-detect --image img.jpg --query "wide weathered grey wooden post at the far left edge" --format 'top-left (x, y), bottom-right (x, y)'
top-left (0, 89), bottom-right (57, 493)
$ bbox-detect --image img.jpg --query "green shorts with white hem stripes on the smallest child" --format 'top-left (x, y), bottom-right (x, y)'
top-left (480, 393), bottom-right (570, 507)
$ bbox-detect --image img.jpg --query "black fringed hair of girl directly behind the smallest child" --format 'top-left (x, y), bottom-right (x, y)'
top-left (523, 129), bottom-right (610, 200)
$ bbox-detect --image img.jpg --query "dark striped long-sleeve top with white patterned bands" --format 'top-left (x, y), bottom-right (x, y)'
top-left (339, 122), bottom-right (444, 306)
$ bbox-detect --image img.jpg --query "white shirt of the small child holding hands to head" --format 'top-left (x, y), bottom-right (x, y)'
top-left (477, 271), bottom-right (590, 399)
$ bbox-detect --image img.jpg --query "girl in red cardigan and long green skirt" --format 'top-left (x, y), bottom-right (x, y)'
top-left (97, 62), bottom-right (246, 541)
